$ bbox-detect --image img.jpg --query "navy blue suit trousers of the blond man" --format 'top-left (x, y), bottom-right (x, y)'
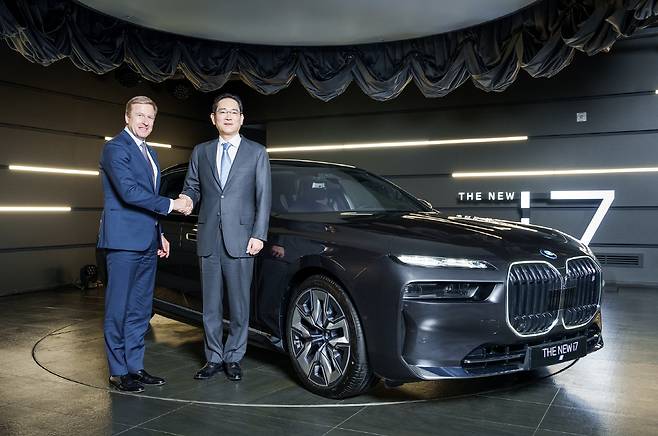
top-left (104, 232), bottom-right (158, 375)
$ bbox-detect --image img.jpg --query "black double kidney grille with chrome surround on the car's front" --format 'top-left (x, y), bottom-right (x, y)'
top-left (507, 257), bottom-right (601, 336)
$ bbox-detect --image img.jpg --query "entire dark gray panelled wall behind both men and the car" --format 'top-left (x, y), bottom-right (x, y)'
top-left (0, 30), bottom-right (658, 294)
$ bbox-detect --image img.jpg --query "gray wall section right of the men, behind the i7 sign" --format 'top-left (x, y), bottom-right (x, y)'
top-left (247, 34), bottom-right (658, 285)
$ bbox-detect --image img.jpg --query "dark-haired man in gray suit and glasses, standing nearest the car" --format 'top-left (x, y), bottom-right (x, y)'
top-left (181, 94), bottom-right (272, 380)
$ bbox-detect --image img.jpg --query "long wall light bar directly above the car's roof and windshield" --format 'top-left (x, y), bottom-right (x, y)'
top-left (267, 136), bottom-right (528, 153)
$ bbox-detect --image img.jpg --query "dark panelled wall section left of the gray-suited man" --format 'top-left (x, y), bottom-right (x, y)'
top-left (0, 45), bottom-right (213, 295)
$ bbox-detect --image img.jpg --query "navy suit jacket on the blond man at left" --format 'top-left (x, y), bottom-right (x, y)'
top-left (98, 130), bottom-right (170, 251)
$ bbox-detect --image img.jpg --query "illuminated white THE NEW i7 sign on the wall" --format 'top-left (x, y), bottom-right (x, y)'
top-left (457, 190), bottom-right (615, 245)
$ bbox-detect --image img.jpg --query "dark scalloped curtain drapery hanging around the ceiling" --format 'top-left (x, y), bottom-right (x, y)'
top-left (0, 0), bottom-right (658, 101)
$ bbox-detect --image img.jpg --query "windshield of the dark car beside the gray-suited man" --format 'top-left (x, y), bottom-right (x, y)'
top-left (272, 165), bottom-right (431, 214)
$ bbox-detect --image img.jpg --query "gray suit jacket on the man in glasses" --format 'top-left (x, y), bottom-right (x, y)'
top-left (183, 136), bottom-right (272, 257)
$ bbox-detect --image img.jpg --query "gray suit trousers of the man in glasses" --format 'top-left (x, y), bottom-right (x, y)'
top-left (199, 231), bottom-right (254, 363)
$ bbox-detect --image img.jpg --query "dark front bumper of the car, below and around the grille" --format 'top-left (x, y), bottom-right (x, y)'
top-left (351, 255), bottom-right (603, 382)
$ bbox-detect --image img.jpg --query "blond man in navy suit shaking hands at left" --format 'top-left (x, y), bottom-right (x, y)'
top-left (98, 96), bottom-right (187, 392)
